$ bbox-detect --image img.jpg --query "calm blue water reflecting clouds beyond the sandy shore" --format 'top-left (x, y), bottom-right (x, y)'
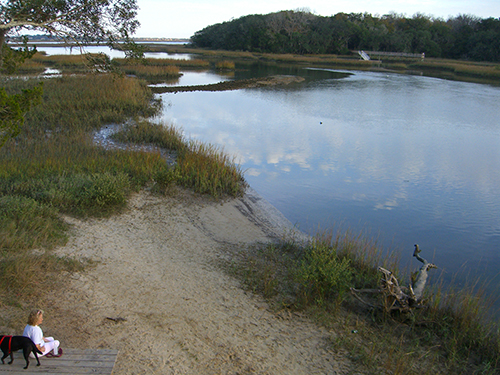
top-left (156, 69), bottom-right (500, 288)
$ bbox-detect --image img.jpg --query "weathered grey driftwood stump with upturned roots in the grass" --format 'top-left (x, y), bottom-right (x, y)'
top-left (351, 244), bottom-right (437, 312)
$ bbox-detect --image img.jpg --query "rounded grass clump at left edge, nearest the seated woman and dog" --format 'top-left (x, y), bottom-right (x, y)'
top-left (0, 186), bottom-right (87, 306)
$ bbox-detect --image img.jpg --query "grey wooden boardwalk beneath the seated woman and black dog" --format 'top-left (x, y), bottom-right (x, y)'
top-left (0, 348), bottom-right (118, 375)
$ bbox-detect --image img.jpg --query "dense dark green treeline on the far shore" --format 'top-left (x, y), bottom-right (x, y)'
top-left (191, 11), bottom-right (500, 61)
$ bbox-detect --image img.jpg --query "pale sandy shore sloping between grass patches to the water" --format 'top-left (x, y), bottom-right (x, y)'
top-left (43, 191), bottom-right (346, 375)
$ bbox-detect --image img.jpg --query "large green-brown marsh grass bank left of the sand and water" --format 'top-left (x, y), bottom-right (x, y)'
top-left (0, 74), bottom-right (245, 312)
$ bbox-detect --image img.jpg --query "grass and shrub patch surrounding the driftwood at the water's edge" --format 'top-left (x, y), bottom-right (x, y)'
top-left (224, 231), bottom-right (500, 374)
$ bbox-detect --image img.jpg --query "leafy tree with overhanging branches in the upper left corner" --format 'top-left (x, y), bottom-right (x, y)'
top-left (0, 0), bottom-right (140, 147)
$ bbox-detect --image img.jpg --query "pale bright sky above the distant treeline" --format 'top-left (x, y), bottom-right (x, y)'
top-left (135, 0), bottom-right (500, 38)
